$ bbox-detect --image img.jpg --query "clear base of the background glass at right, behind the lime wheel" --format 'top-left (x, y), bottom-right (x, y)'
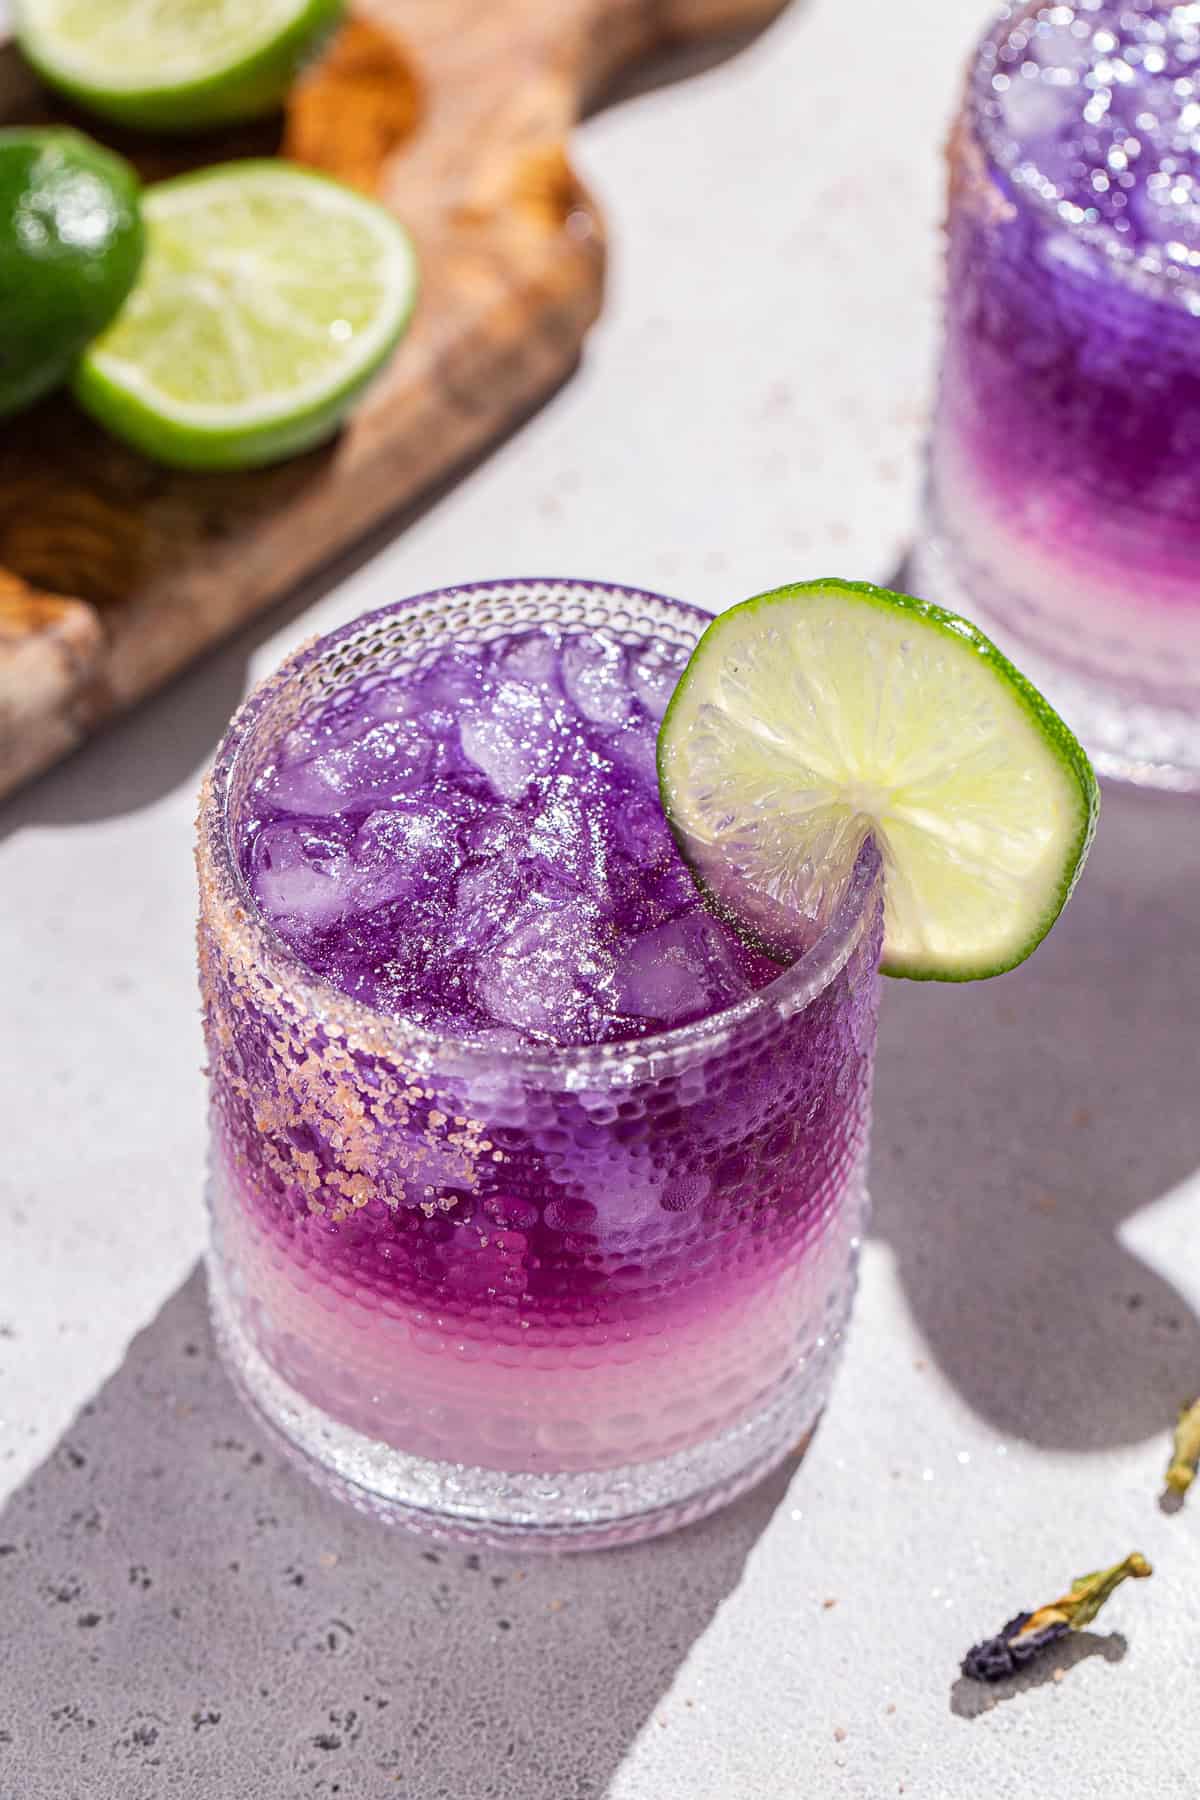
top-left (910, 533), bottom-right (1200, 794)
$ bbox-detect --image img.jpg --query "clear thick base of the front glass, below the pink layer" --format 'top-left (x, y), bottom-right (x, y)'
top-left (209, 1256), bottom-right (855, 1550)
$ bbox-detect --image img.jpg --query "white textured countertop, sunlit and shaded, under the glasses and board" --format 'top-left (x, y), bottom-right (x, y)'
top-left (0, 0), bottom-right (1200, 1800)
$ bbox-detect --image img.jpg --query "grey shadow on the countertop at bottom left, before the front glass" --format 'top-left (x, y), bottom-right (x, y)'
top-left (0, 1271), bottom-right (795, 1800)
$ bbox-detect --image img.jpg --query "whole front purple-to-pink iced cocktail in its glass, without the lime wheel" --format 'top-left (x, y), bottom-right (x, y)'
top-left (200, 581), bottom-right (882, 1544)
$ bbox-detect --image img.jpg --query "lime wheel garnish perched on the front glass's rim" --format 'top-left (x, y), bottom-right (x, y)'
top-left (658, 581), bottom-right (1099, 981)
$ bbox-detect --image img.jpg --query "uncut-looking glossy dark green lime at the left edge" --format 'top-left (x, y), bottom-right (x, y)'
top-left (0, 128), bottom-right (144, 418)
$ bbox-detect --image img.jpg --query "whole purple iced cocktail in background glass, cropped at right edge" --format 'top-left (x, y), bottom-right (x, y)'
top-left (918, 0), bottom-right (1200, 787)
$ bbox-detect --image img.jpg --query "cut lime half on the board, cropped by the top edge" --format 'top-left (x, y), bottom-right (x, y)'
top-left (14, 0), bottom-right (340, 131)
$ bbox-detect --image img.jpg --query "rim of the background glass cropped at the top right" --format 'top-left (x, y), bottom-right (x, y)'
top-left (963, 0), bottom-right (1200, 315)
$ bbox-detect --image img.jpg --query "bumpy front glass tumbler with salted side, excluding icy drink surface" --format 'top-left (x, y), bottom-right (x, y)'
top-left (198, 581), bottom-right (882, 1548)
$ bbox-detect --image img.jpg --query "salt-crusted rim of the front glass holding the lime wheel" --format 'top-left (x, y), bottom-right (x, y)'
top-left (198, 576), bottom-right (883, 1087)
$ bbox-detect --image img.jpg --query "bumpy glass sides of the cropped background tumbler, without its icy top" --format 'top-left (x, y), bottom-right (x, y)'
top-left (914, 4), bottom-right (1200, 788)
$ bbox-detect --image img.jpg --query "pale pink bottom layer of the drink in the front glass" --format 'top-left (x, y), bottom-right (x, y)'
top-left (216, 1172), bottom-right (865, 1472)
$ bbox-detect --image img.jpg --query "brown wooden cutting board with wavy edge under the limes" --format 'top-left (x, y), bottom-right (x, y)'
top-left (0, 0), bottom-right (783, 794)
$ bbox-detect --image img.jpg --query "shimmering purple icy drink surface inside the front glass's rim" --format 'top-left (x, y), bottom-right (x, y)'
top-left (241, 628), bottom-right (779, 1046)
